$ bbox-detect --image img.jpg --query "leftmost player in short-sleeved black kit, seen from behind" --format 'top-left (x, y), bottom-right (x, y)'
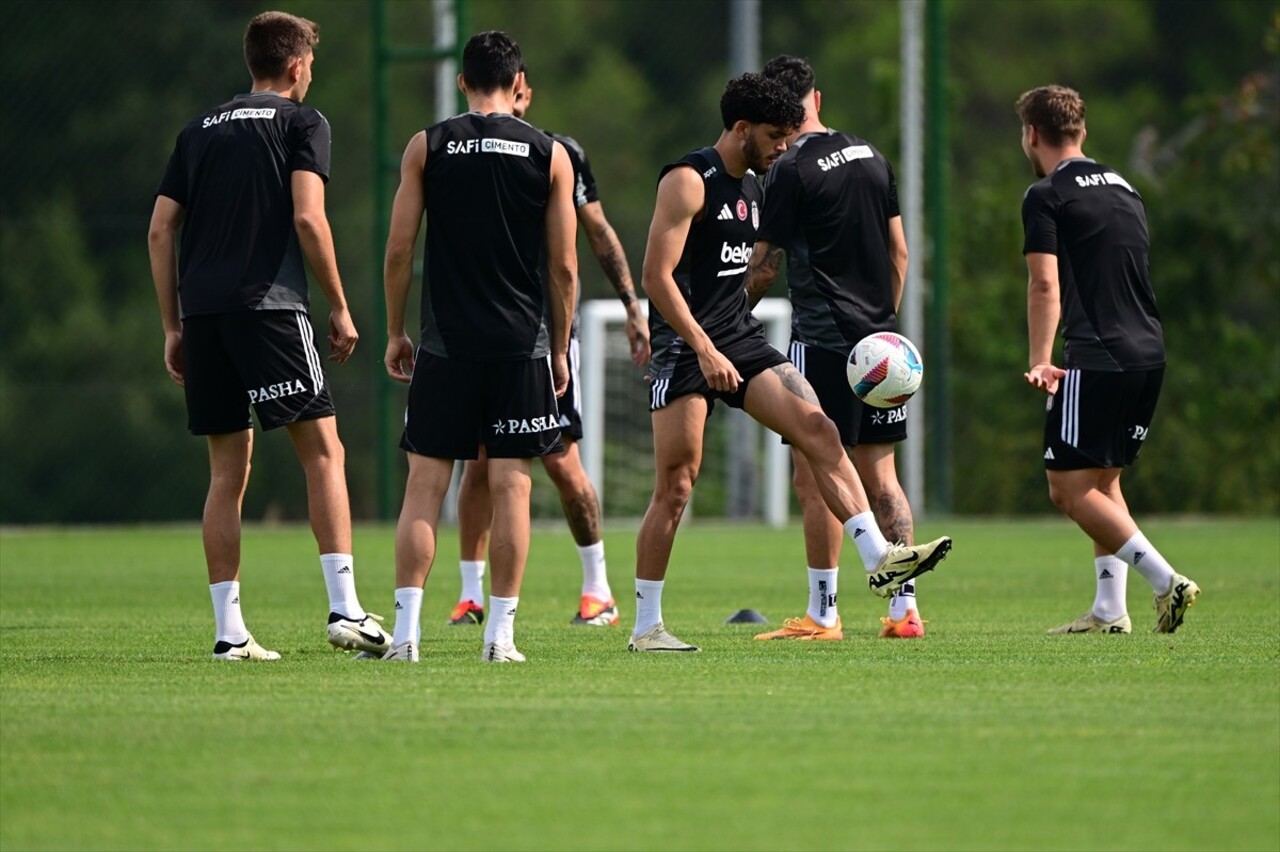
top-left (148, 12), bottom-right (390, 660)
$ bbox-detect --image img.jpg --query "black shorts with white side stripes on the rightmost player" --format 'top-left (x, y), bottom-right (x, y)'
top-left (1044, 367), bottom-right (1165, 471)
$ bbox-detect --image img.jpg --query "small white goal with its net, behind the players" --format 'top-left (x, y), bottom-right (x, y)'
top-left (579, 298), bottom-right (791, 527)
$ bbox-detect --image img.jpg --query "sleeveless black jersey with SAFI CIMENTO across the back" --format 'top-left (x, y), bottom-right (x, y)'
top-left (422, 113), bottom-right (554, 361)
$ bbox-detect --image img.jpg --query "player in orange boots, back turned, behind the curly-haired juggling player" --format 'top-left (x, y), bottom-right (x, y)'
top-left (746, 55), bottom-right (924, 640)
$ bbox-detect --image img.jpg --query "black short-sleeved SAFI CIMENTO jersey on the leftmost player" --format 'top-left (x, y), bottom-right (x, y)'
top-left (156, 92), bottom-right (330, 317)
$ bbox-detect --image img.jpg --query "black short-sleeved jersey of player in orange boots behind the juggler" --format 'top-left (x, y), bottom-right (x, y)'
top-left (759, 129), bottom-right (900, 354)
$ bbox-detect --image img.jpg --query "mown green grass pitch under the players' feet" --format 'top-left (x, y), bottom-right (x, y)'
top-left (0, 518), bottom-right (1280, 851)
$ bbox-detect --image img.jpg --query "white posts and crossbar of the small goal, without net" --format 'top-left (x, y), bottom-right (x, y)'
top-left (579, 298), bottom-right (791, 527)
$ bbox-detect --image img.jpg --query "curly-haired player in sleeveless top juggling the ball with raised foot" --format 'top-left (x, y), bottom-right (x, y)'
top-left (628, 74), bottom-right (951, 651)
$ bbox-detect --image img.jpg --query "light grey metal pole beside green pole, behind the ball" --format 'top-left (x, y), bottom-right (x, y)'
top-left (899, 0), bottom-right (932, 516)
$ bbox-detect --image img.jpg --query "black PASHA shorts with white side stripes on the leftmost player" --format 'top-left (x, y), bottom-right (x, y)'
top-left (182, 310), bottom-right (334, 435)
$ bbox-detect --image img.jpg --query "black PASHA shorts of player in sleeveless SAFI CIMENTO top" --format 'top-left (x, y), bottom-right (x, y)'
top-left (401, 347), bottom-right (564, 459)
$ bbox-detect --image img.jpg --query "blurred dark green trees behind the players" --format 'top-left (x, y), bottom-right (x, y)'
top-left (0, 0), bottom-right (1280, 523)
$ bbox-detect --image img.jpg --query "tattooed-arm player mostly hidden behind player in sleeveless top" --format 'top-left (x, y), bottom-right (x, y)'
top-left (449, 69), bottom-right (649, 627)
